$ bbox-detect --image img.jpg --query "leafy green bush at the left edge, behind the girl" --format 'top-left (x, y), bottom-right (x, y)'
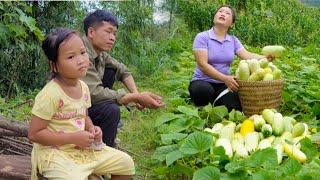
top-left (0, 2), bottom-right (46, 98)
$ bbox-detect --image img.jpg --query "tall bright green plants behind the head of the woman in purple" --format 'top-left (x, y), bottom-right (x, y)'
top-left (176, 0), bottom-right (320, 46)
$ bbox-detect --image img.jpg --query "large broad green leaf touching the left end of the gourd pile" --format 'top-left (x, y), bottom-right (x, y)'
top-left (180, 132), bottom-right (213, 154)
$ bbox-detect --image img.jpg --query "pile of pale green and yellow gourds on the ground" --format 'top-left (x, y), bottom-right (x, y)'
top-left (204, 109), bottom-right (311, 164)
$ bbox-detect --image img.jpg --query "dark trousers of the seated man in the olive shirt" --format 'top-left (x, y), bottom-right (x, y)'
top-left (88, 68), bottom-right (120, 147)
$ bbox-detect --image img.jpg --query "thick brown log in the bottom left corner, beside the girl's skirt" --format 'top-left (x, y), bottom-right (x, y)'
top-left (0, 155), bottom-right (31, 179)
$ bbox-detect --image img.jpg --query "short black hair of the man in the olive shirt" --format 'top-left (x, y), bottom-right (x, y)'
top-left (83, 9), bottom-right (118, 35)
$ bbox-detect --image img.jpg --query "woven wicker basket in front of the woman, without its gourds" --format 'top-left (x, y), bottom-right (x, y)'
top-left (237, 80), bottom-right (284, 116)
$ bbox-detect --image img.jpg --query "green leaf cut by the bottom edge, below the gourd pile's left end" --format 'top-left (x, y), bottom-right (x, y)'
top-left (192, 166), bottom-right (220, 180)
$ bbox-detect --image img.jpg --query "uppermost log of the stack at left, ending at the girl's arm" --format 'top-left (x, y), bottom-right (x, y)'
top-left (0, 115), bottom-right (29, 137)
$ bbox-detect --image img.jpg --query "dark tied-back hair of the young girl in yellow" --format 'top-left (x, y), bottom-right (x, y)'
top-left (42, 28), bottom-right (77, 79)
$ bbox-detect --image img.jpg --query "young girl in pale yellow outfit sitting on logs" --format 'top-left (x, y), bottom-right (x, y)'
top-left (28, 28), bottom-right (134, 180)
